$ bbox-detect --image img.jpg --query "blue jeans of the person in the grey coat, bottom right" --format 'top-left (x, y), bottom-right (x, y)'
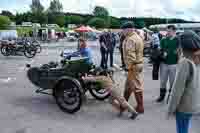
top-left (176, 112), bottom-right (192, 133)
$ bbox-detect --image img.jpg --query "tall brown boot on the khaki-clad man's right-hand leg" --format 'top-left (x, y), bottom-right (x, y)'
top-left (135, 92), bottom-right (144, 114)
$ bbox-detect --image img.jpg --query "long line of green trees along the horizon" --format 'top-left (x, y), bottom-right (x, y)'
top-left (0, 0), bottom-right (197, 29)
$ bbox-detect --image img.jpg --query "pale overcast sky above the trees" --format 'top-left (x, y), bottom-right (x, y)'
top-left (0, 0), bottom-right (200, 21)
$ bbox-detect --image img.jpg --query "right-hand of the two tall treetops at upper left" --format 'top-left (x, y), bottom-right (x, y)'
top-left (49, 0), bottom-right (63, 13)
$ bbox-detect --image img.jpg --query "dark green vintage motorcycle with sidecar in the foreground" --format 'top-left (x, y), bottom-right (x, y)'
top-left (27, 54), bottom-right (110, 113)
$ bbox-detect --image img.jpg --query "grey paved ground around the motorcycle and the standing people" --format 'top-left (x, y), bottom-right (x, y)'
top-left (0, 42), bottom-right (200, 133)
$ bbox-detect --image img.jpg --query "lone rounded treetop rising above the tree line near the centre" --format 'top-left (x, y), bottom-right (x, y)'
top-left (93, 6), bottom-right (109, 17)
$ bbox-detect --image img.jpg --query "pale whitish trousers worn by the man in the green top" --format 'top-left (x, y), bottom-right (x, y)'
top-left (160, 63), bottom-right (176, 89)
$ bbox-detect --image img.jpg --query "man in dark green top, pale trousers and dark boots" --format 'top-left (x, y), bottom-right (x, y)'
top-left (156, 25), bottom-right (179, 102)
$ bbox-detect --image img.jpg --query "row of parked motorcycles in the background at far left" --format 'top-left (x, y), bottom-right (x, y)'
top-left (1, 38), bottom-right (42, 58)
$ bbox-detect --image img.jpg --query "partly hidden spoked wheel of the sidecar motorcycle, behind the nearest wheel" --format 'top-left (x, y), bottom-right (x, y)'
top-left (89, 85), bottom-right (110, 101)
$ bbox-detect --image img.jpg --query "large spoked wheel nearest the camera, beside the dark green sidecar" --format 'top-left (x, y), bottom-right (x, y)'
top-left (55, 80), bottom-right (82, 114)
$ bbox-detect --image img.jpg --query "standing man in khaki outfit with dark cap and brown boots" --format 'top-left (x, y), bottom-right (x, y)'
top-left (122, 22), bottom-right (144, 113)
